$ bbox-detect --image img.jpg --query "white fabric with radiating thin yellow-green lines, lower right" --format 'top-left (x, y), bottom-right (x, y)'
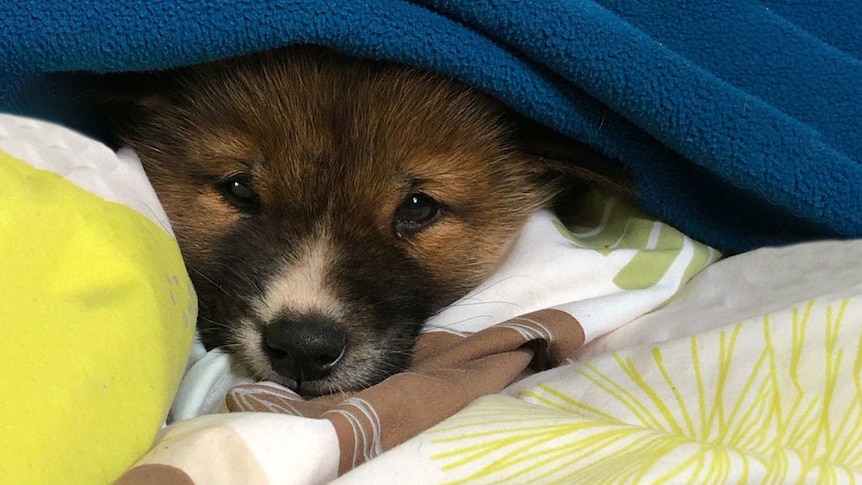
top-left (429, 297), bottom-right (862, 484)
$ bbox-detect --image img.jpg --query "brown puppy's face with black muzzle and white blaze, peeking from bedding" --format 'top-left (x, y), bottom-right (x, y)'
top-left (99, 48), bottom-right (628, 394)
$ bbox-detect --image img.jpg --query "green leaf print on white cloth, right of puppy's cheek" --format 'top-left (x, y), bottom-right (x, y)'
top-left (555, 192), bottom-right (718, 290)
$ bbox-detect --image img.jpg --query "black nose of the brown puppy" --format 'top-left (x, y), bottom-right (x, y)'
top-left (264, 315), bottom-right (347, 386)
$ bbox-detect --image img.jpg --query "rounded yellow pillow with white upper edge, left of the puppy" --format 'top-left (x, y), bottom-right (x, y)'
top-left (0, 115), bottom-right (197, 485)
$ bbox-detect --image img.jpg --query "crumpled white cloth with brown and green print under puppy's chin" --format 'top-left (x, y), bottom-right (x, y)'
top-left (122, 192), bottom-right (718, 483)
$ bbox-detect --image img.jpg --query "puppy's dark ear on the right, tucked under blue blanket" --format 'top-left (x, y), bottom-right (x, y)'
top-left (516, 120), bottom-right (637, 199)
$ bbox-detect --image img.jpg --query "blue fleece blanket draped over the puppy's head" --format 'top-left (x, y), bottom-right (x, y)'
top-left (0, 0), bottom-right (862, 251)
